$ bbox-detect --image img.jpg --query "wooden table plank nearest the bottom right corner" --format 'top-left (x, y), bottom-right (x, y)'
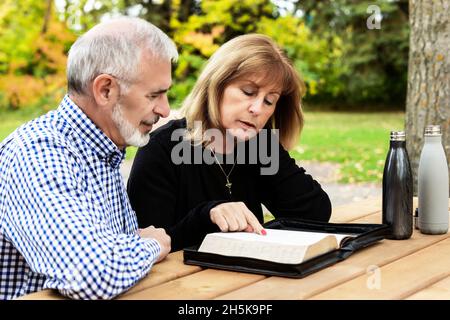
top-left (311, 236), bottom-right (450, 299)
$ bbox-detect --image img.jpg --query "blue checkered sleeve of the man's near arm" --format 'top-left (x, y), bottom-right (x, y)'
top-left (6, 139), bottom-right (161, 299)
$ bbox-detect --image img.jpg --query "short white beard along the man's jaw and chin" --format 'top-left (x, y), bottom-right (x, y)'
top-left (112, 103), bottom-right (150, 147)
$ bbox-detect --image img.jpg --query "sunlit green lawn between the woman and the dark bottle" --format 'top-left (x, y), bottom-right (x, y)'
top-left (290, 112), bottom-right (405, 183)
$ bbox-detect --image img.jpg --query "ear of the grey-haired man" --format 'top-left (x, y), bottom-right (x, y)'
top-left (92, 74), bottom-right (120, 106)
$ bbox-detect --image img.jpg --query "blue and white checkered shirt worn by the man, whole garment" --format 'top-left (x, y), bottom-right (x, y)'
top-left (0, 96), bottom-right (161, 299)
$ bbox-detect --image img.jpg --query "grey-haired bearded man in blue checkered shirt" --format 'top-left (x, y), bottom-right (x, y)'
top-left (0, 18), bottom-right (178, 299)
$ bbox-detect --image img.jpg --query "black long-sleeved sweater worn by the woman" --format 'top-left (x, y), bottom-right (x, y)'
top-left (128, 119), bottom-right (331, 251)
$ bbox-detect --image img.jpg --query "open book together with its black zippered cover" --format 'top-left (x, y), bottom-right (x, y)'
top-left (183, 218), bottom-right (390, 278)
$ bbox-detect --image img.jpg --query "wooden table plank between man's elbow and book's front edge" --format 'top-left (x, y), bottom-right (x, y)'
top-left (121, 269), bottom-right (265, 300)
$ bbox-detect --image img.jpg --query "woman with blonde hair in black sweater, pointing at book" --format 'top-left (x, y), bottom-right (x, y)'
top-left (128, 34), bottom-right (331, 251)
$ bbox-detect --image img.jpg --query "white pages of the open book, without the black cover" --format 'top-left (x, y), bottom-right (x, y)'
top-left (198, 229), bottom-right (352, 264)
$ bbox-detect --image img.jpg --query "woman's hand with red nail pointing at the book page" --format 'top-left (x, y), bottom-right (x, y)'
top-left (209, 202), bottom-right (266, 235)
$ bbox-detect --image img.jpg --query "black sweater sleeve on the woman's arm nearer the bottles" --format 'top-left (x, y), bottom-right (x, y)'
top-left (259, 145), bottom-right (331, 221)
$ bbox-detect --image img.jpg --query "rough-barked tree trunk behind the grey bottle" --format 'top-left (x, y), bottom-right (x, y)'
top-left (406, 0), bottom-right (450, 194)
